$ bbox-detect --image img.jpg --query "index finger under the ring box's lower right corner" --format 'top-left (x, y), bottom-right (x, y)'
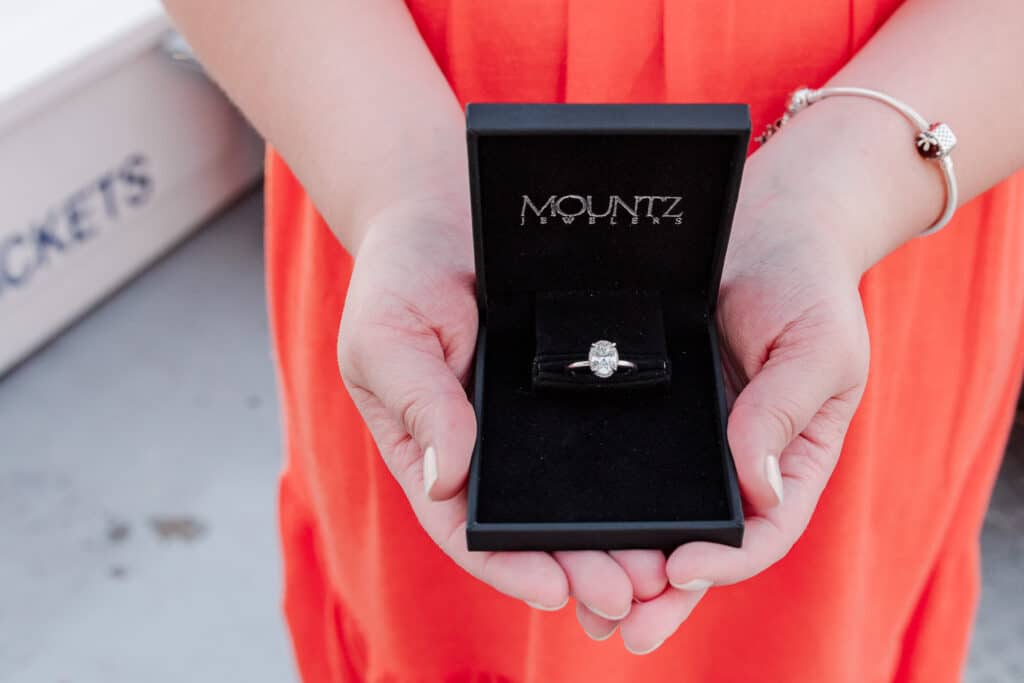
top-left (666, 437), bottom-right (835, 592)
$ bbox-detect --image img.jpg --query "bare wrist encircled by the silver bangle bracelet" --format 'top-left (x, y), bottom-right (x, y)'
top-left (749, 92), bottom-right (945, 273)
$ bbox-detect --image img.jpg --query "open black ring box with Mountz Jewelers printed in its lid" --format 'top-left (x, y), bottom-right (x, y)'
top-left (466, 104), bottom-right (750, 550)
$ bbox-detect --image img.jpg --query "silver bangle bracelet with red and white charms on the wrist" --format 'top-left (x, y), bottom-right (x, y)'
top-left (755, 86), bottom-right (957, 238)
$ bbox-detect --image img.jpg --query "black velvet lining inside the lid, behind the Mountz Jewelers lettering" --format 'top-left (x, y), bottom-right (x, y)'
top-left (476, 134), bottom-right (735, 311)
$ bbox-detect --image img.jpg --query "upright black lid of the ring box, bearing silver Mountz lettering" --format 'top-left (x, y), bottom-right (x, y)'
top-left (467, 103), bottom-right (751, 313)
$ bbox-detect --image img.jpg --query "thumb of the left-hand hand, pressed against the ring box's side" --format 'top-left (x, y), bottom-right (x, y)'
top-left (338, 323), bottom-right (476, 500)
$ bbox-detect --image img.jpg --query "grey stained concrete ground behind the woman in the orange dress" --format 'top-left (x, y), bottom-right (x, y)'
top-left (0, 188), bottom-right (1024, 683)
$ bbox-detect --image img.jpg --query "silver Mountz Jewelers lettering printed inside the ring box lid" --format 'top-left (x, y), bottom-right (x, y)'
top-left (519, 195), bottom-right (683, 225)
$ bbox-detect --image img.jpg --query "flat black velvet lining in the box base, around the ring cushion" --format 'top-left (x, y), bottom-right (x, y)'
top-left (477, 295), bottom-right (731, 522)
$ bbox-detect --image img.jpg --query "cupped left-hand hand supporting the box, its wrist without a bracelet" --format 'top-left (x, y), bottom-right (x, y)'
top-left (338, 202), bottom-right (668, 626)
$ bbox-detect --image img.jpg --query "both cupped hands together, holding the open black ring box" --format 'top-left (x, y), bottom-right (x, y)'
top-left (338, 174), bottom-right (868, 653)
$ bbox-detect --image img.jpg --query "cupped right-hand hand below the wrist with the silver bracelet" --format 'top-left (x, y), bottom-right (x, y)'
top-left (587, 183), bottom-right (868, 652)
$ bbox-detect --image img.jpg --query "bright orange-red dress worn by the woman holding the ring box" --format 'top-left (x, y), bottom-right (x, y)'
top-left (266, 0), bottom-right (1024, 683)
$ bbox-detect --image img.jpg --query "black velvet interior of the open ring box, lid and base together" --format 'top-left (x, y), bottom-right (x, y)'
top-left (471, 108), bottom-right (749, 523)
